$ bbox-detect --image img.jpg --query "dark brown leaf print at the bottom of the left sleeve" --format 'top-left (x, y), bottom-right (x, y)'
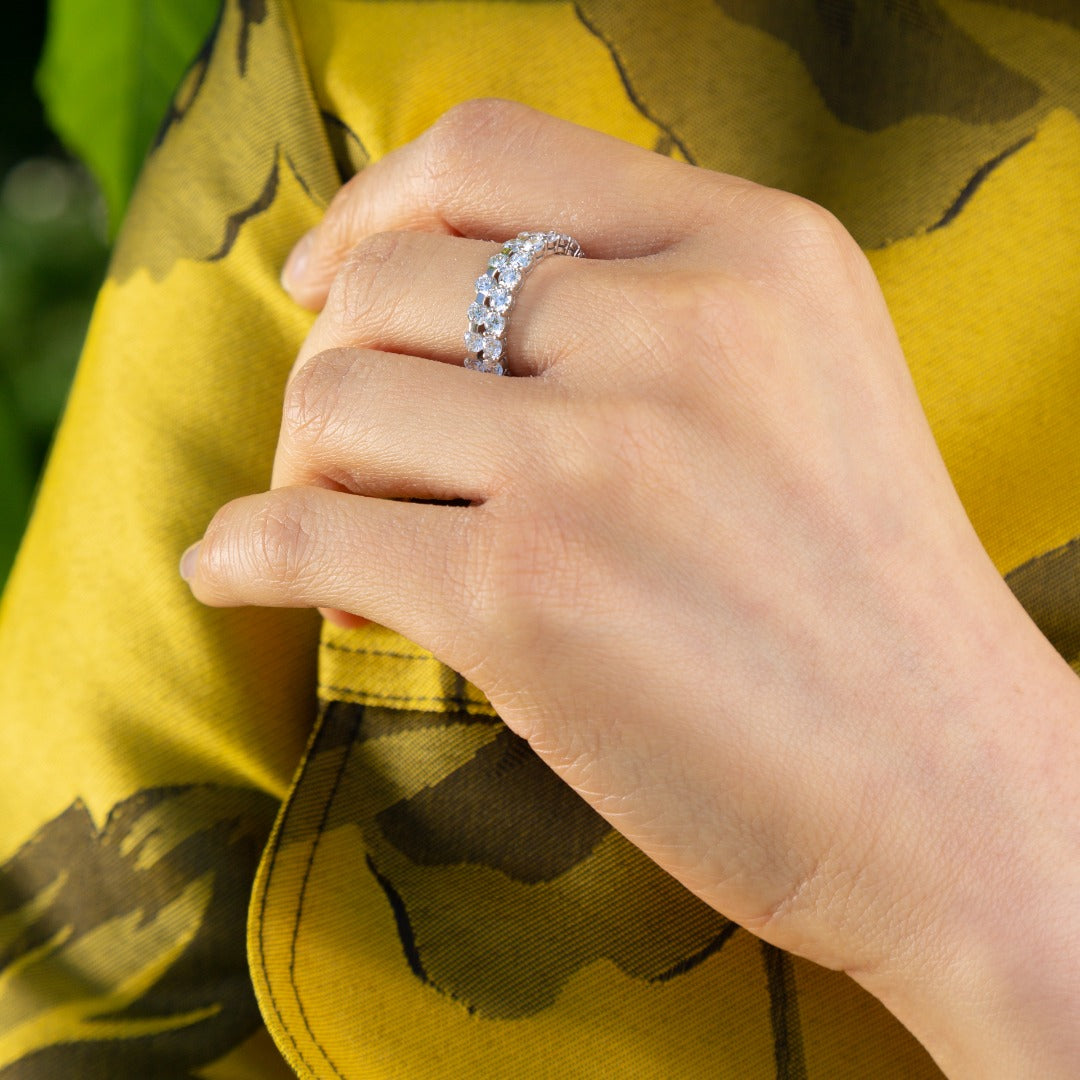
top-left (0, 784), bottom-right (278, 1080)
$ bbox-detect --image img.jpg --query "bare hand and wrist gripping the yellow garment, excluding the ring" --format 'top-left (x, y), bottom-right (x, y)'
top-left (184, 100), bottom-right (1080, 1080)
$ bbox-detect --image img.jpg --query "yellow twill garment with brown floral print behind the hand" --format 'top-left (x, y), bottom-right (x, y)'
top-left (0, 0), bottom-right (1080, 1080)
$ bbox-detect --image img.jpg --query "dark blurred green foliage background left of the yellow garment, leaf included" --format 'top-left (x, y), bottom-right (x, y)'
top-left (0, 0), bottom-right (218, 588)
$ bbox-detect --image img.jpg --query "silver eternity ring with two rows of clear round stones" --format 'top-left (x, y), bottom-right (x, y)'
top-left (465, 232), bottom-right (584, 375)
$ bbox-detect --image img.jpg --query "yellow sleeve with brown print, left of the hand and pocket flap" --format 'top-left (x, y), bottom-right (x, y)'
top-left (0, 3), bottom-right (332, 1080)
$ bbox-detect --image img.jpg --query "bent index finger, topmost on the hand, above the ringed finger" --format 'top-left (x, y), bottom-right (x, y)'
top-left (282, 98), bottom-right (756, 309)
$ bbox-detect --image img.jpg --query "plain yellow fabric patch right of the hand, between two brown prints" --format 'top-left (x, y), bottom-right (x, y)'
top-left (869, 106), bottom-right (1080, 578)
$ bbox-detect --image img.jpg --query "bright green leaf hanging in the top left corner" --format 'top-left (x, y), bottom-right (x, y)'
top-left (37, 0), bottom-right (219, 231)
